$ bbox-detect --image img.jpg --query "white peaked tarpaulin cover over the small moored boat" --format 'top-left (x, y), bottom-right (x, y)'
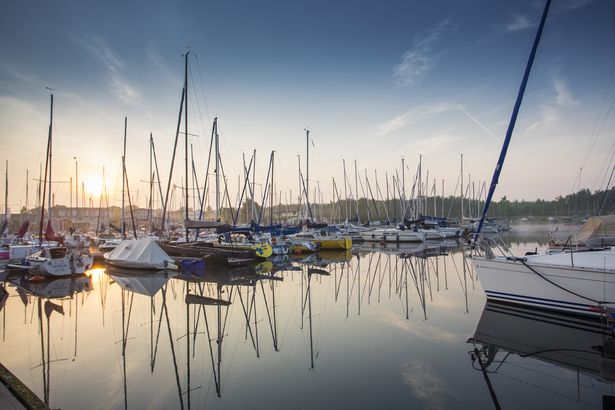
top-left (104, 238), bottom-right (178, 270)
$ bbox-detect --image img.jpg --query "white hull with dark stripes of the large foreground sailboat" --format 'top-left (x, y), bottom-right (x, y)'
top-left (472, 250), bottom-right (615, 315)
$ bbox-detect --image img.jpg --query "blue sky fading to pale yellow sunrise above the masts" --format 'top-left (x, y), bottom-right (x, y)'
top-left (0, 0), bottom-right (615, 215)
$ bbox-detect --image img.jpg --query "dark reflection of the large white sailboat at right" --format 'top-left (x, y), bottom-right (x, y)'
top-left (468, 302), bottom-right (615, 408)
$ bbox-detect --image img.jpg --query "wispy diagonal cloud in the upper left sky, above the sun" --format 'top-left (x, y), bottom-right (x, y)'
top-left (73, 36), bottom-right (141, 105)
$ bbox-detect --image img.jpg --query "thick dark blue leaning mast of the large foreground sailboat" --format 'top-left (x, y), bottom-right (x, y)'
top-left (474, 0), bottom-right (551, 243)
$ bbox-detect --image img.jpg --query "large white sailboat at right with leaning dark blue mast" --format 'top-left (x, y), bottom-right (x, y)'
top-left (471, 0), bottom-right (615, 316)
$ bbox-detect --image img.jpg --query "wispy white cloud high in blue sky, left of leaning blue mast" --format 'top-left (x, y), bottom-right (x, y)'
top-left (393, 18), bottom-right (450, 87)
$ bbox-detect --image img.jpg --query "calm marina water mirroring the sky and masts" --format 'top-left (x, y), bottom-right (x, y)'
top-left (0, 231), bottom-right (615, 409)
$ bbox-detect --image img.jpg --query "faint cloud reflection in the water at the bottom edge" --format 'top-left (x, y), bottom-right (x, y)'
top-left (401, 362), bottom-right (453, 409)
